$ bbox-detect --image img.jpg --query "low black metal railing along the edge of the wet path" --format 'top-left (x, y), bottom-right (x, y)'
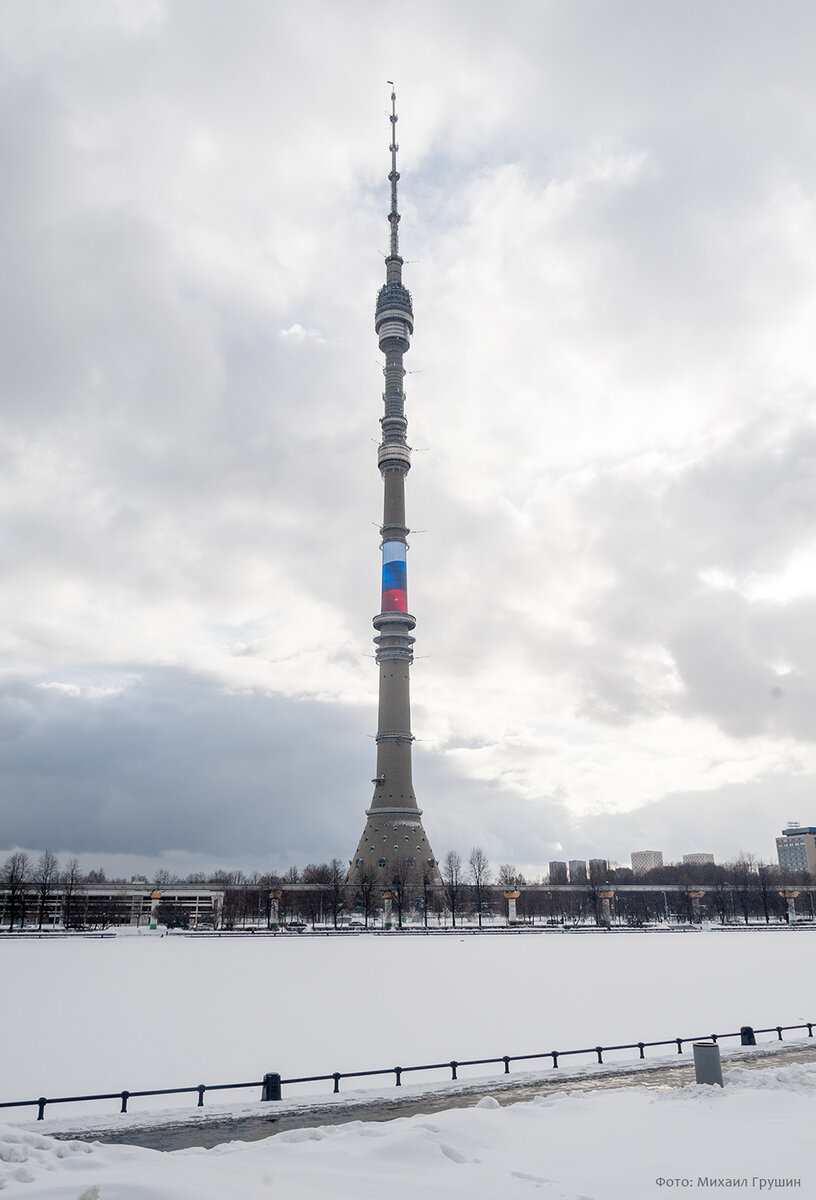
top-left (0, 1021), bottom-right (816, 1121)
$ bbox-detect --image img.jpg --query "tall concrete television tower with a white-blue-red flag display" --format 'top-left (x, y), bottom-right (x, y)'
top-left (349, 91), bottom-right (439, 886)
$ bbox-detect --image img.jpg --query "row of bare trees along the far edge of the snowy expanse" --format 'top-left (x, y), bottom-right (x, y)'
top-left (0, 846), bottom-right (812, 929)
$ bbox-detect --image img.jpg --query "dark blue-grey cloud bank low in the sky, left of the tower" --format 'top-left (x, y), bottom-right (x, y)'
top-left (0, 671), bottom-right (373, 870)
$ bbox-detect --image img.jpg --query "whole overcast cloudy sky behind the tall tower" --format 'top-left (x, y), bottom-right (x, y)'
top-left (0, 0), bottom-right (816, 875)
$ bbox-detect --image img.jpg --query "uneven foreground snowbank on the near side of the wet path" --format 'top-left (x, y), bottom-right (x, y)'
top-left (0, 1066), bottom-right (816, 1200)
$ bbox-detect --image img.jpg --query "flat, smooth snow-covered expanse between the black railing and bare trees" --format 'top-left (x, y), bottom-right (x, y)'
top-left (0, 930), bottom-right (816, 1129)
